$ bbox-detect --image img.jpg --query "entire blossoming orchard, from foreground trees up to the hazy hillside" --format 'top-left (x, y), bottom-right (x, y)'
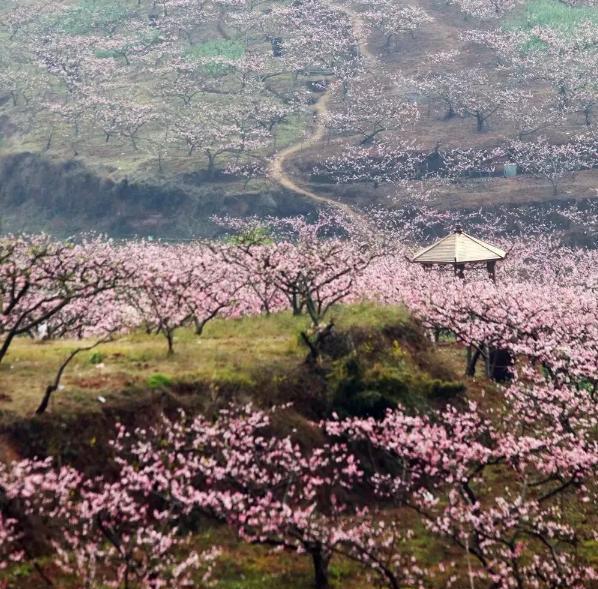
top-left (0, 0), bottom-right (598, 589)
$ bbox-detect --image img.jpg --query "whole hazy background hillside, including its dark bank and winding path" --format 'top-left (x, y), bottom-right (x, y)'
top-left (0, 0), bottom-right (596, 238)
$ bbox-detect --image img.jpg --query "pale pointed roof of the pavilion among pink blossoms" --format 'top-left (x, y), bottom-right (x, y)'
top-left (412, 229), bottom-right (507, 264)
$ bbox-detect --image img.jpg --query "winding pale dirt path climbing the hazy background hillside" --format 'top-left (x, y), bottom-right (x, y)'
top-left (268, 2), bottom-right (377, 217)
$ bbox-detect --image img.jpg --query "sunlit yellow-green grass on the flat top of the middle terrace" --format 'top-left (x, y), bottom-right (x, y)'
top-left (0, 304), bottom-right (406, 415)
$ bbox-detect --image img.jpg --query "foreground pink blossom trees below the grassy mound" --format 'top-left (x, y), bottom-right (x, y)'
top-left (0, 372), bottom-right (598, 589)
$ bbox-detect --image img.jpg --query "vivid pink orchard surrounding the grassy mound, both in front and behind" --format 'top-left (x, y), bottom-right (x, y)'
top-left (0, 211), bottom-right (598, 589)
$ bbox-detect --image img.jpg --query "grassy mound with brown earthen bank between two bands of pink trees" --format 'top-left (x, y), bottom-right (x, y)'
top-left (0, 304), bottom-right (463, 468)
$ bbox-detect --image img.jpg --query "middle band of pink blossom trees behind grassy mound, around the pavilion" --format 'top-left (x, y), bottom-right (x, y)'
top-left (0, 215), bottom-right (598, 408)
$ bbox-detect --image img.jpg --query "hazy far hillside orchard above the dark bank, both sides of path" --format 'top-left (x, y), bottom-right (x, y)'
top-left (0, 0), bottom-right (598, 202)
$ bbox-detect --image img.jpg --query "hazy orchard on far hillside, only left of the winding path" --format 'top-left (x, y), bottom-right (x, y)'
top-left (0, 0), bottom-right (358, 176)
